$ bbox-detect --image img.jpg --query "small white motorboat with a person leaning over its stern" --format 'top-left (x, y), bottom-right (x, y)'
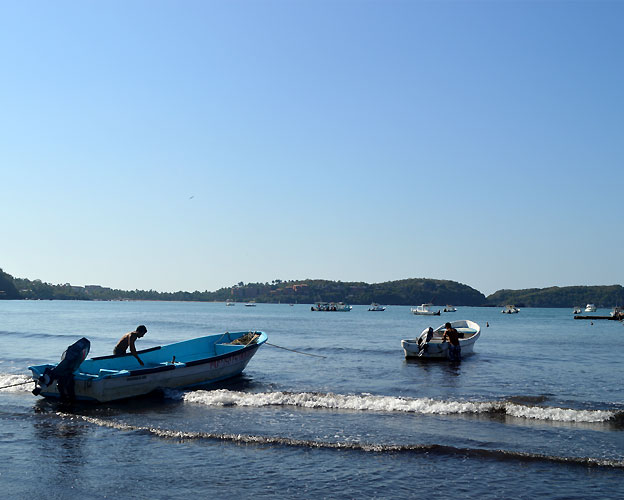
top-left (401, 320), bottom-right (481, 358)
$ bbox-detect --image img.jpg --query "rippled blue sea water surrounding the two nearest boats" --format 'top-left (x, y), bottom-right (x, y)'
top-left (0, 301), bottom-right (624, 499)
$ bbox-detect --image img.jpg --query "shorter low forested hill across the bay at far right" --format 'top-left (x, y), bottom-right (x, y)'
top-left (487, 285), bottom-right (624, 308)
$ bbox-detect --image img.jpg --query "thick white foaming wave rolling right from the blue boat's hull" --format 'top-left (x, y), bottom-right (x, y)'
top-left (180, 389), bottom-right (621, 423)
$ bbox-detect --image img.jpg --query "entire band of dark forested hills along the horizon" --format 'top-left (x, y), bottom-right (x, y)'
top-left (0, 269), bottom-right (624, 307)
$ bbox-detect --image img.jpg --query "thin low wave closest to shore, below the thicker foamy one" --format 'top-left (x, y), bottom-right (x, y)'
top-left (64, 413), bottom-right (624, 469)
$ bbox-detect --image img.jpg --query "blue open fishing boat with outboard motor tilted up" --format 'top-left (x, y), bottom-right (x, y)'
top-left (28, 332), bottom-right (268, 402)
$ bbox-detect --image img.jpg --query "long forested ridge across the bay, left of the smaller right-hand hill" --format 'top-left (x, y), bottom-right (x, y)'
top-left (1, 275), bottom-right (485, 306)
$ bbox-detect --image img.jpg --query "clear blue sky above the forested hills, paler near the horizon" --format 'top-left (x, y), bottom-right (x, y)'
top-left (0, 0), bottom-right (624, 295)
